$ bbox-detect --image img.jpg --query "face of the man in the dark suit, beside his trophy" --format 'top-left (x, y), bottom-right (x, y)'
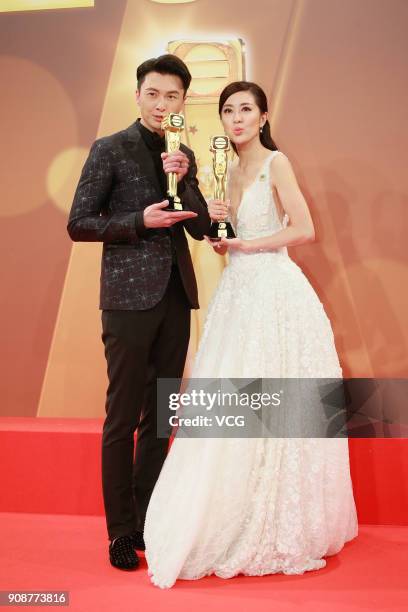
top-left (136, 72), bottom-right (184, 134)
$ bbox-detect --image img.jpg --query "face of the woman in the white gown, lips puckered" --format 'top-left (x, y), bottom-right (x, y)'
top-left (221, 91), bottom-right (267, 146)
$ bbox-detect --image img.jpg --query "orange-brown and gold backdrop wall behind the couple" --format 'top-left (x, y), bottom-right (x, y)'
top-left (0, 0), bottom-right (408, 417)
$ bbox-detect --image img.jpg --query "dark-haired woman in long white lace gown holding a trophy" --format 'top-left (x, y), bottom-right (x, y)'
top-left (144, 81), bottom-right (357, 588)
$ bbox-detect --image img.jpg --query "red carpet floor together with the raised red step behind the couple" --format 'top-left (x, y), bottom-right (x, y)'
top-left (0, 418), bottom-right (408, 612)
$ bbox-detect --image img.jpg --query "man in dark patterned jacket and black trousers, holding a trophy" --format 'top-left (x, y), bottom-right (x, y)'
top-left (68, 55), bottom-right (210, 569)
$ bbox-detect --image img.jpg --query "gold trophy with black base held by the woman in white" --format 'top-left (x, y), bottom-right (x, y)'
top-left (209, 136), bottom-right (235, 242)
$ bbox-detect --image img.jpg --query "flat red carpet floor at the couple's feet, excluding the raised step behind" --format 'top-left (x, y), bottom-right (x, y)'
top-left (0, 513), bottom-right (408, 612)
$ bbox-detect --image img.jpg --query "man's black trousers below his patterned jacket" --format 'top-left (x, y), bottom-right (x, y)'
top-left (102, 266), bottom-right (190, 539)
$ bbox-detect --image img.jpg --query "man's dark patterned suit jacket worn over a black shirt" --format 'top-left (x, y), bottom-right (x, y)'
top-left (68, 122), bottom-right (210, 310)
